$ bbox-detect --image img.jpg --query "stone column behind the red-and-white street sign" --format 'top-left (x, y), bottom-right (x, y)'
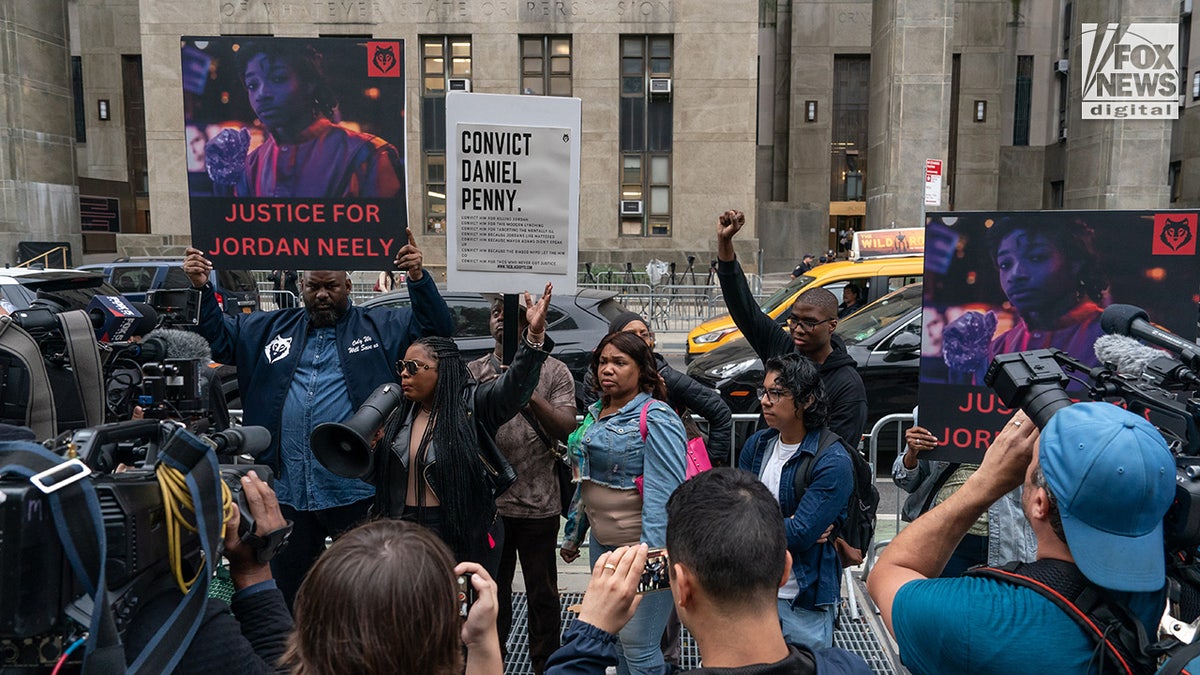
top-left (866, 0), bottom-right (954, 229)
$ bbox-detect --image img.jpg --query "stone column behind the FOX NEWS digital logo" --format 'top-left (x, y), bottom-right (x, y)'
top-left (1063, 0), bottom-right (1171, 209)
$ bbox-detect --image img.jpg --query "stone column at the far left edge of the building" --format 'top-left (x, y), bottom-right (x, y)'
top-left (0, 0), bottom-right (83, 265)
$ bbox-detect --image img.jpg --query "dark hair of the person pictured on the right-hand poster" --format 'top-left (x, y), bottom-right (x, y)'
top-left (988, 213), bottom-right (1109, 301)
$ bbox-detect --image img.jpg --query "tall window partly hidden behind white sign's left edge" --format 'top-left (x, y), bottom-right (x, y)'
top-left (421, 36), bottom-right (472, 234)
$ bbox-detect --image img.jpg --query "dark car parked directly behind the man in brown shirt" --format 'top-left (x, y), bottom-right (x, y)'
top-left (362, 288), bottom-right (625, 403)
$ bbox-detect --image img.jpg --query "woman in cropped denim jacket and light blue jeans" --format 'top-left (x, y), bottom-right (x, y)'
top-left (560, 333), bottom-right (686, 675)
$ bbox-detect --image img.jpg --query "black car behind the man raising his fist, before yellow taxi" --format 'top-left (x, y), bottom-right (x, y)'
top-left (688, 283), bottom-right (922, 461)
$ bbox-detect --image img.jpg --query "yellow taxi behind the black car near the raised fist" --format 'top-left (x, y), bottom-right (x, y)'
top-left (684, 256), bottom-right (925, 363)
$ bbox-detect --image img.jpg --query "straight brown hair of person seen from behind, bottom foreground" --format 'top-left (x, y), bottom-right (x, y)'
top-left (282, 520), bottom-right (462, 675)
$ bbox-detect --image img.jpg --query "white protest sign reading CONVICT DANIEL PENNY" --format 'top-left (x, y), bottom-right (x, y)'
top-left (446, 91), bottom-right (582, 294)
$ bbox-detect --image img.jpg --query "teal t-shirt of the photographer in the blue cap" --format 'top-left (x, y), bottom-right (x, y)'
top-left (892, 577), bottom-right (1165, 675)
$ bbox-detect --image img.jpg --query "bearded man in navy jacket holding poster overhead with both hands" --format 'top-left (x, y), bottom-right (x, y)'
top-left (184, 229), bottom-right (454, 607)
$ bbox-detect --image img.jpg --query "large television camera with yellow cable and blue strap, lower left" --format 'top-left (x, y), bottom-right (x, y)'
top-left (0, 419), bottom-right (280, 673)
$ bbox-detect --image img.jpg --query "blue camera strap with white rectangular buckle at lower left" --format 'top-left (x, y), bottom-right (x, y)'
top-left (0, 442), bottom-right (125, 675)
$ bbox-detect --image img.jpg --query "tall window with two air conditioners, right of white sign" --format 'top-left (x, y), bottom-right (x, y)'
top-left (619, 35), bottom-right (674, 237)
